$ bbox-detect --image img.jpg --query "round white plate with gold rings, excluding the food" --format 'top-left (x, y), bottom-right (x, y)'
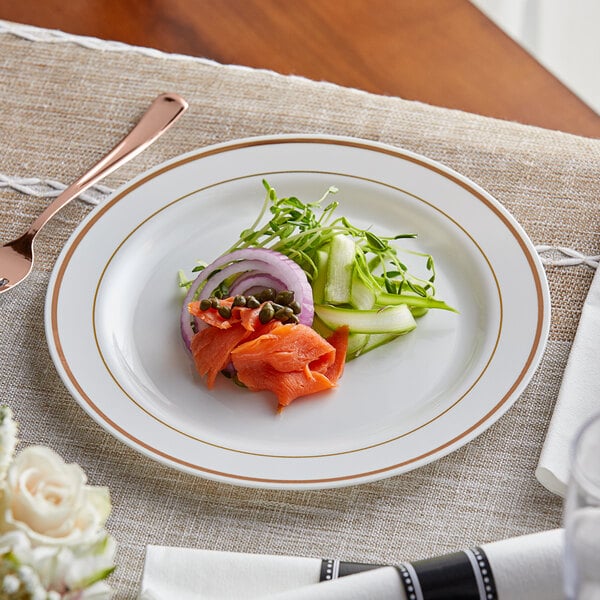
top-left (46, 136), bottom-right (549, 488)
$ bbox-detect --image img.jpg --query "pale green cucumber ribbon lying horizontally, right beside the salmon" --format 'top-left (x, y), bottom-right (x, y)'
top-left (315, 304), bottom-right (417, 334)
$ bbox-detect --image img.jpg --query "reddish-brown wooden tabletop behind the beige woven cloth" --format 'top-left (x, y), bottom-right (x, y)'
top-left (0, 0), bottom-right (600, 137)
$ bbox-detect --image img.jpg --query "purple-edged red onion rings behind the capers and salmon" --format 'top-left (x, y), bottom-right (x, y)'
top-left (180, 248), bottom-right (314, 350)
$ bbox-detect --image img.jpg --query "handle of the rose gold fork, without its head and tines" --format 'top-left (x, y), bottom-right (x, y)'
top-left (25, 93), bottom-right (188, 238)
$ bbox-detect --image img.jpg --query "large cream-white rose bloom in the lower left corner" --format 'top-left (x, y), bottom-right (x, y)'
top-left (3, 446), bottom-right (111, 546)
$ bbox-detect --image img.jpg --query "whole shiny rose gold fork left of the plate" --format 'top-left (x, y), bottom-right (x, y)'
top-left (0, 94), bottom-right (188, 294)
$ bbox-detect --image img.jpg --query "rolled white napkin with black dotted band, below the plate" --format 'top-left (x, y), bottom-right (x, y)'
top-left (139, 529), bottom-right (564, 600)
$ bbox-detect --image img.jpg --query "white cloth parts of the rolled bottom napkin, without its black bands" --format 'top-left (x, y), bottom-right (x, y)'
top-left (140, 529), bottom-right (563, 600)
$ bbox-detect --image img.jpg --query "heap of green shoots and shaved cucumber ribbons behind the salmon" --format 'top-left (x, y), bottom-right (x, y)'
top-left (225, 180), bottom-right (456, 360)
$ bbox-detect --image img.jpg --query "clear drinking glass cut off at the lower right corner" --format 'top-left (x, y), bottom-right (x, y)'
top-left (565, 414), bottom-right (600, 600)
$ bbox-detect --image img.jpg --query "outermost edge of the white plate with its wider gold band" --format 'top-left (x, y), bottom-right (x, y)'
top-left (45, 134), bottom-right (551, 489)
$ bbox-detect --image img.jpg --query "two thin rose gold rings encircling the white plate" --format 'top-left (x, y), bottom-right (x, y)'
top-left (51, 136), bottom-right (545, 485)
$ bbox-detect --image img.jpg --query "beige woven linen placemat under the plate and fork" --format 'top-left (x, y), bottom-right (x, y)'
top-left (0, 22), bottom-right (600, 598)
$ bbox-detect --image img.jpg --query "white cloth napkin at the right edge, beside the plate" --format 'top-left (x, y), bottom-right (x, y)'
top-left (535, 268), bottom-right (600, 496)
